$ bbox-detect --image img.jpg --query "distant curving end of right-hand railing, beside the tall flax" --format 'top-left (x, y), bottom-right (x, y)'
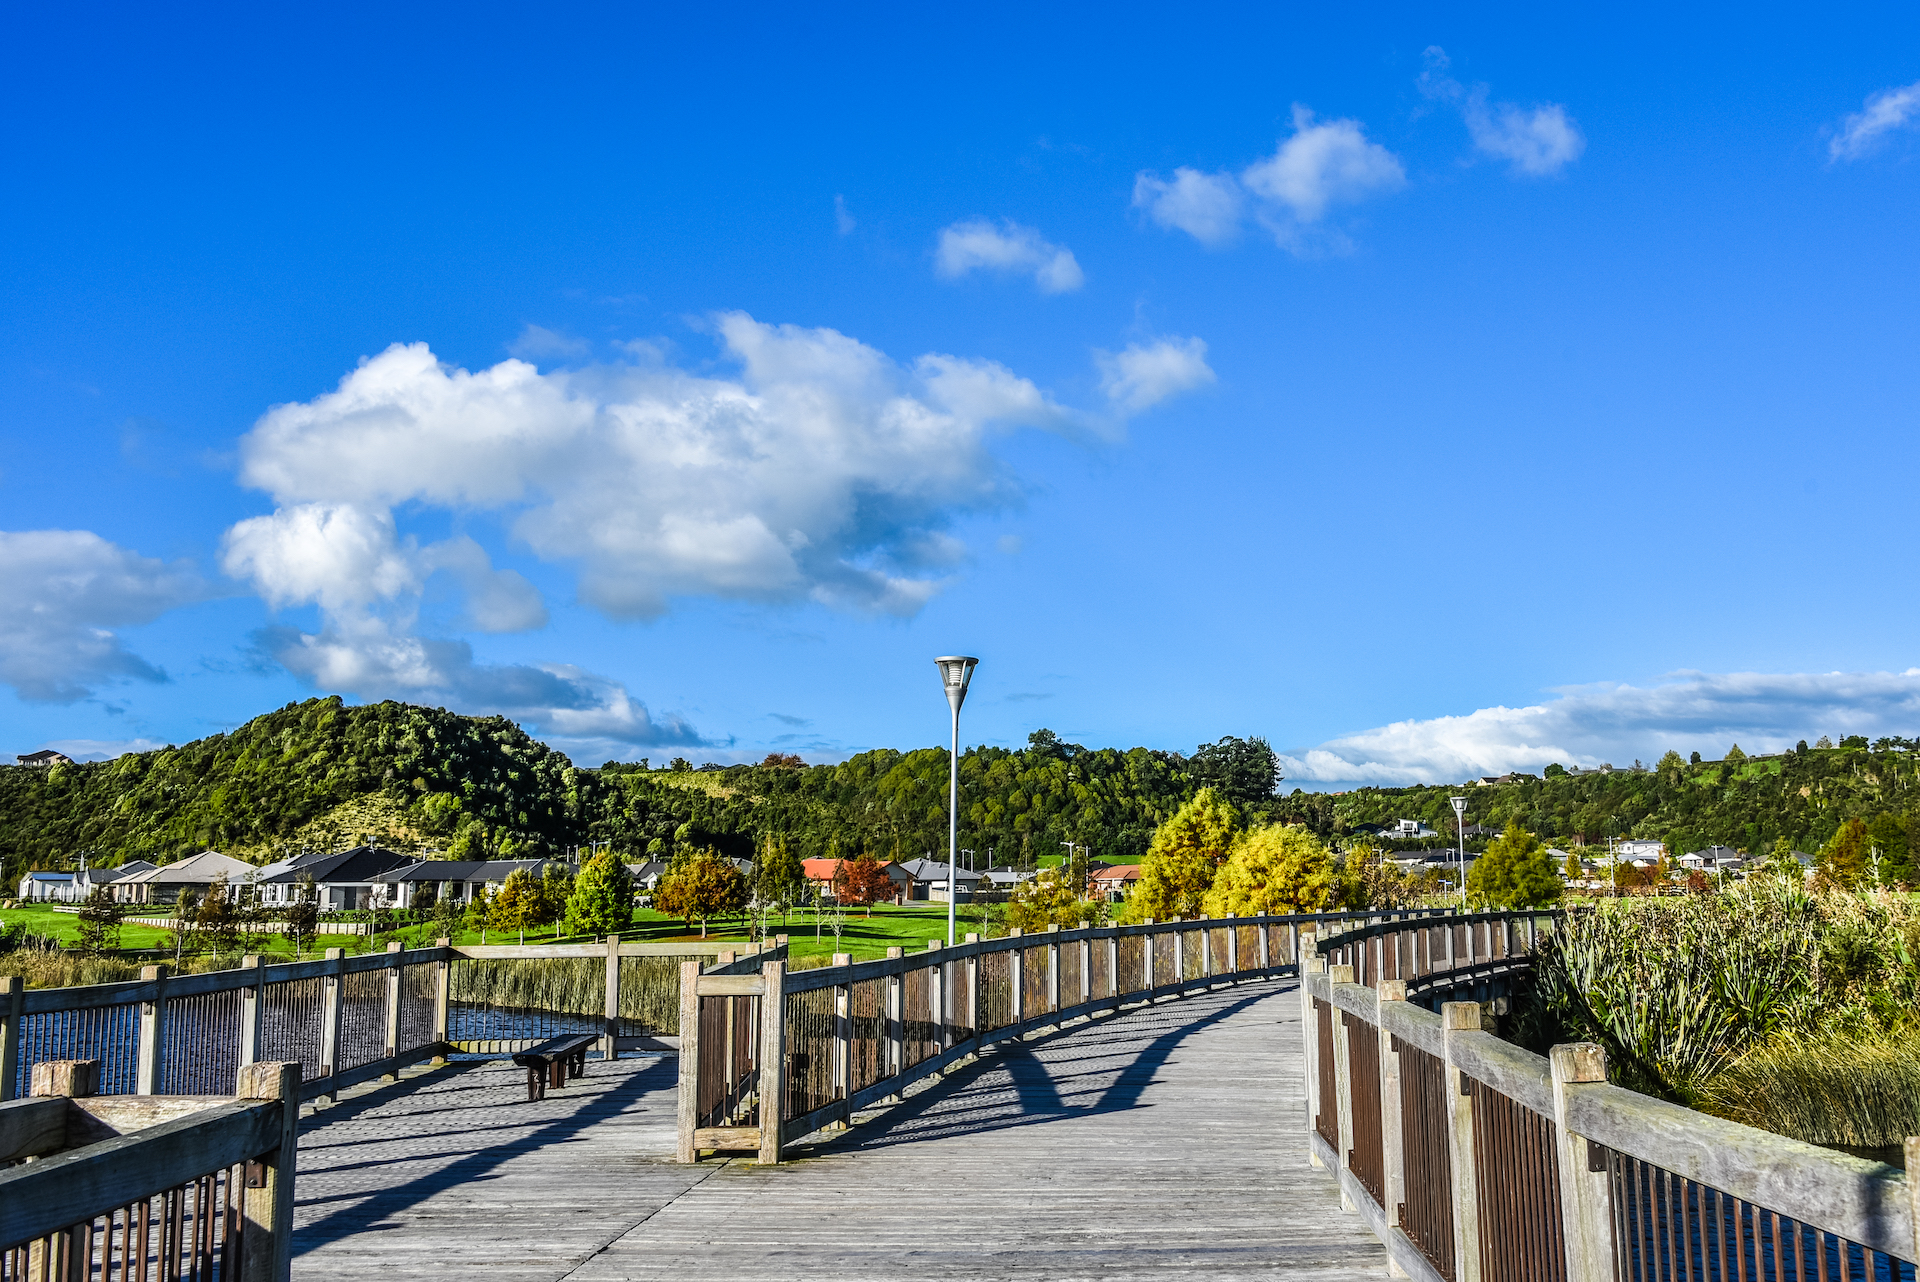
top-left (1315, 910), bottom-right (1563, 1009)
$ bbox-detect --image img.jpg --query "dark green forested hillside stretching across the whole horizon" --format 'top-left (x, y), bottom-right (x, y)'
top-left (0, 699), bottom-right (1920, 881)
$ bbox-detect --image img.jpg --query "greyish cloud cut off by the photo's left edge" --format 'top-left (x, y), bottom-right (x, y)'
top-left (0, 530), bottom-right (205, 702)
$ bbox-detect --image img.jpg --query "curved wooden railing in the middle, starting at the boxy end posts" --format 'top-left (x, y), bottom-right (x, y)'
top-left (680, 910), bottom-right (1440, 1163)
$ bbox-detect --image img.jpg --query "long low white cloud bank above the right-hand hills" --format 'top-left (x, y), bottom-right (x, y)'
top-left (1281, 668), bottom-right (1920, 785)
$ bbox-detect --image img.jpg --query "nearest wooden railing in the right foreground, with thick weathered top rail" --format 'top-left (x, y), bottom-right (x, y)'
top-left (1302, 954), bottom-right (1920, 1282)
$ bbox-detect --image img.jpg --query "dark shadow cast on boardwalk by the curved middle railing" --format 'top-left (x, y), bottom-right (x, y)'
top-left (799, 979), bottom-right (1296, 1151)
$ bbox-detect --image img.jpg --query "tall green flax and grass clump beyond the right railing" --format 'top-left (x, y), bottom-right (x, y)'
top-left (1519, 877), bottom-right (1920, 1146)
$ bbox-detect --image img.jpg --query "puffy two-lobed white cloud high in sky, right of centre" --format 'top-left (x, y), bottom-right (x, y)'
top-left (1133, 104), bottom-right (1407, 253)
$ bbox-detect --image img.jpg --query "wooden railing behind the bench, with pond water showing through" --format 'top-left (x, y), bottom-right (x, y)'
top-left (0, 938), bottom-right (764, 1102)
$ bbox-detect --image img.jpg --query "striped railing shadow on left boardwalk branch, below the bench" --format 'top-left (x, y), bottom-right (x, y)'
top-left (294, 1057), bottom-right (680, 1255)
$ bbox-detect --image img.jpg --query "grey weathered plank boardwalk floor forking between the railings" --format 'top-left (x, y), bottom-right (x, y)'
top-left (294, 981), bottom-right (1386, 1282)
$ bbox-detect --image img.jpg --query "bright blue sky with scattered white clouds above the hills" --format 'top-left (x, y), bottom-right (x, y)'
top-left (0, 6), bottom-right (1920, 787)
